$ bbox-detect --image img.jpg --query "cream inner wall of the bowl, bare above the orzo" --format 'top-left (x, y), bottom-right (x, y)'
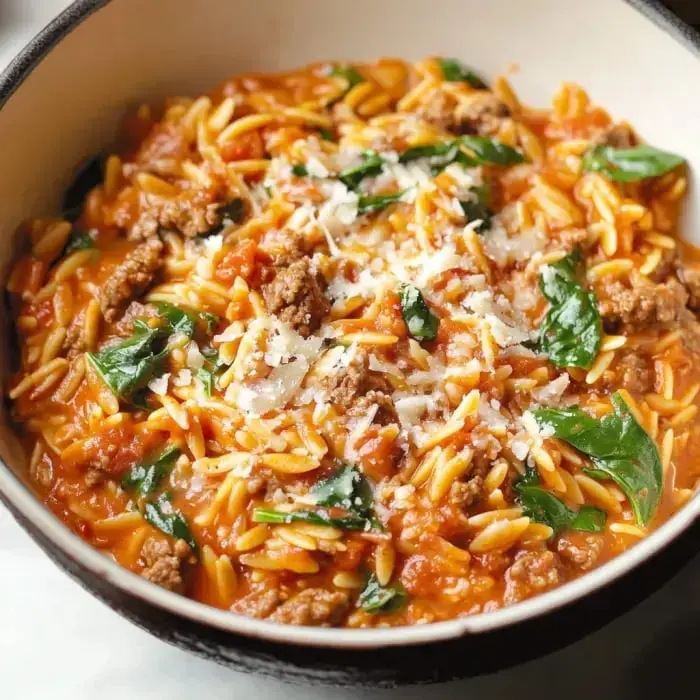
top-left (0, 0), bottom-right (700, 643)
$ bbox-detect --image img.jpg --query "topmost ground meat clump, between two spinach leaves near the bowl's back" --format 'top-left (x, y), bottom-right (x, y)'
top-left (418, 91), bottom-right (510, 136)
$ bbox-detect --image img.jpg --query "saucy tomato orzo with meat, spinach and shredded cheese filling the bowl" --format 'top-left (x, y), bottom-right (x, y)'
top-left (8, 58), bottom-right (700, 627)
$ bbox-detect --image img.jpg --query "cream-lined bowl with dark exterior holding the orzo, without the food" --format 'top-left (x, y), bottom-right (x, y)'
top-left (0, 0), bottom-right (700, 687)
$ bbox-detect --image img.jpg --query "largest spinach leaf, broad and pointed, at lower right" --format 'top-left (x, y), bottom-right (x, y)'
top-left (533, 393), bottom-right (663, 525)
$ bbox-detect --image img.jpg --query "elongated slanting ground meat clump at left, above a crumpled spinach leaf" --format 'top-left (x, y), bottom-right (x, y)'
top-left (99, 238), bottom-right (163, 322)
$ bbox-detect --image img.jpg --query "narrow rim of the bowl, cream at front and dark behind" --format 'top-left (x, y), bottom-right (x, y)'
top-left (0, 0), bottom-right (700, 649)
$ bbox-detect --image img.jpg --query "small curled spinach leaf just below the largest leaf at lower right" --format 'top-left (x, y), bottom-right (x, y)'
top-left (514, 469), bottom-right (607, 533)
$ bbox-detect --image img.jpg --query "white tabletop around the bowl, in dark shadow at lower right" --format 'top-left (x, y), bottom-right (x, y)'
top-left (0, 0), bottom-right (700, 700)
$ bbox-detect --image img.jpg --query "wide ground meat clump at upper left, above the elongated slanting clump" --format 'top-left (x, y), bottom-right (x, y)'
top-left (129, 190), bottom-right (221, 241)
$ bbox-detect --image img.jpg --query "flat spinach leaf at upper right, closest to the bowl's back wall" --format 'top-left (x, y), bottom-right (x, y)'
top-left (581, 145), bottom-right (685, 182)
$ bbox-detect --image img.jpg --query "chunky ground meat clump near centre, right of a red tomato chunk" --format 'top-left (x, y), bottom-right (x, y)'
top-left (262, 258), bottom-right (331, 338)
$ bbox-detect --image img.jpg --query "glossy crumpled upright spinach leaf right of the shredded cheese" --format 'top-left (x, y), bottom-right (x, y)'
top-left (540, 249), bottom-right (602, 369)
